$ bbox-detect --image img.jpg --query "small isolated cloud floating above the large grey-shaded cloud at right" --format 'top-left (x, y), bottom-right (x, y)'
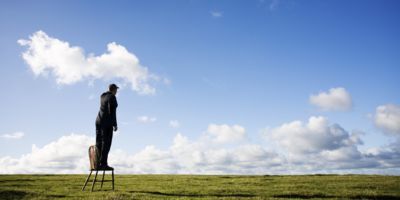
top-left (310, 87), bottom-right (353, 111)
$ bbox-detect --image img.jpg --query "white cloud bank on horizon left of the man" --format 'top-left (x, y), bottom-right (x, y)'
top-left (0, 134), bottom-right (95, 174)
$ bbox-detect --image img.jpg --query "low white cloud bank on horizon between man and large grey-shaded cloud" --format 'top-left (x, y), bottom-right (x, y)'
top-left (110, 130), bottom-right (282, 174)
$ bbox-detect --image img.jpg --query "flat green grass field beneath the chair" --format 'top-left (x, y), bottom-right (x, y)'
top-left (0, 175), bottom-right (400, 199)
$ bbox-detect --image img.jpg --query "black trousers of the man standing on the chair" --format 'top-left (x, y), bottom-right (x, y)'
top-left (96, 125), bottom-right (113, 166)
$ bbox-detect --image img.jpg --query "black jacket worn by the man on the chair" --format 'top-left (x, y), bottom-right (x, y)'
top-left (96, 92), bottom-right (118, 128)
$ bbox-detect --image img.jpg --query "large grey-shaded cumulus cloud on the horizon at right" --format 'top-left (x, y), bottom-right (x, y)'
top-left (264, 116), bottom-right (392, 173)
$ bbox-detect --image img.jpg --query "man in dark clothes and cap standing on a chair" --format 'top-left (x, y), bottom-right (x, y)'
top-left (96, 84), bottom-right (119, 170)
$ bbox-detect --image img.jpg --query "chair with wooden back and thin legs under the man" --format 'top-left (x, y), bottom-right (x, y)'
top-left (82, 145), bottom-right (114, 192)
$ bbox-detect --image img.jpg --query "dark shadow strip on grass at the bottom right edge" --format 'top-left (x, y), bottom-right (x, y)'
top-left (273, 194), bottom-right (400, 200)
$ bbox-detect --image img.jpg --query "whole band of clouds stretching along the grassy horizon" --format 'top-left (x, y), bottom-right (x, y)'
top-left (0, 122), bottom-right (400, 174)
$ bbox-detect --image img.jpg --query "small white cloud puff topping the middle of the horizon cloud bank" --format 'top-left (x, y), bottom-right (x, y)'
top-left (207, 124), bottom-right (246, 143)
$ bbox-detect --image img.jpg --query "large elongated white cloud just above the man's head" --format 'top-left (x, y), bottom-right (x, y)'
top-left (18, 31), bottom-right (159, 94)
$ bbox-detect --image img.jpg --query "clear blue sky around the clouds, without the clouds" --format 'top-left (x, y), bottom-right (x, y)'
top-left (0, 0), bottom-right (400, 173)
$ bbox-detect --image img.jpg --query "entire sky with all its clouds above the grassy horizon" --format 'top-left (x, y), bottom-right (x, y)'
top-left (0, 0), bottom-right (400, 175)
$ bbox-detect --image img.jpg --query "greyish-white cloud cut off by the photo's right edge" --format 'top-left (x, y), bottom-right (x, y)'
top-left (374, 104), bottom-right (400, 136)
